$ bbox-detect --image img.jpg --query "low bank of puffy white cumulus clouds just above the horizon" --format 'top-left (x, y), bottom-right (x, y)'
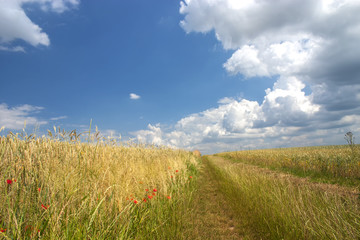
top-left (133, 77), bottom-right (342, 153)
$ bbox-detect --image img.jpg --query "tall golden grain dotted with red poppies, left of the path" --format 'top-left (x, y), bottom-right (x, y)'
top-left (0, 132), bottom-right (198, 239)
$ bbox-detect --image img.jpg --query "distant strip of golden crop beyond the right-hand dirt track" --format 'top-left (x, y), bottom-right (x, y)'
top-left (219, 145), bottom-right (360, 187)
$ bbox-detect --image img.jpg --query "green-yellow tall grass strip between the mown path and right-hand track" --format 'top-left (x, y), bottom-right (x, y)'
top-left (205, 157), bottom-right (360, 239)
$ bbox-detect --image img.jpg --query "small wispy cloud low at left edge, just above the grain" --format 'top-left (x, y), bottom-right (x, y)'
top-left (0, 103), bottom-right (47, 130)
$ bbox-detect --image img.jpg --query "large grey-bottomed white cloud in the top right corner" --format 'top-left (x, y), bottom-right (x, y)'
top-left (180, 0), bottom-right (360, 85)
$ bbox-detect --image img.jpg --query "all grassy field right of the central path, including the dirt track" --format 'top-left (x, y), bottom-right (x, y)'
top-left (211, 145), bottom-right (360, 239)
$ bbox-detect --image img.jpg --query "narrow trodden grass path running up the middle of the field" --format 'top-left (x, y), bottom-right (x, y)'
top-left (186, 157), bottom-right (248, 240)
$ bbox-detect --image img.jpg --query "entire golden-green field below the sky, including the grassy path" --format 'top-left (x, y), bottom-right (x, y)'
top-left (0, 129), bottom-right (360, 239)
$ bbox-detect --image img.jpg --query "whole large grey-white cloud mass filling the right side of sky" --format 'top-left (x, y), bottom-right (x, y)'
top-left (134, 0), bottom-right (360, 152)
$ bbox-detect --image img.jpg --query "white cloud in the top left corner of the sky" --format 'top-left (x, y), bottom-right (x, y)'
top-left (0, 0), bottom-right (79, 51)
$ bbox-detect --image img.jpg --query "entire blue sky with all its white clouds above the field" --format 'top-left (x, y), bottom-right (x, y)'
top-left (0, 0), bottom-right (360, 153)
